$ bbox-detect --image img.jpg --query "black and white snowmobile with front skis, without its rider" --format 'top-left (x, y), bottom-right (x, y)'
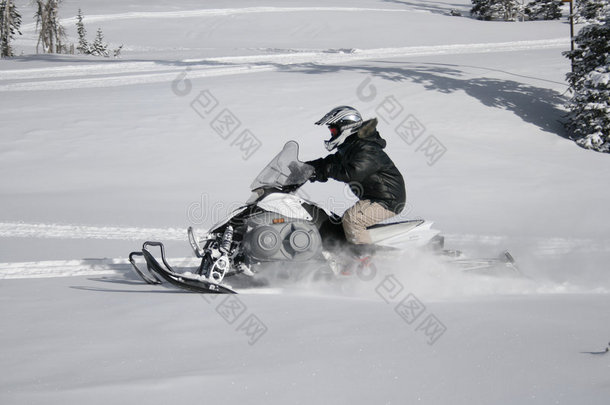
top-left (129, 141), bottom-right (518, 293)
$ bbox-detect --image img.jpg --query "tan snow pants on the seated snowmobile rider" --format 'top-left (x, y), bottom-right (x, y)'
top-left (343, 200), bottom-right (396, 244)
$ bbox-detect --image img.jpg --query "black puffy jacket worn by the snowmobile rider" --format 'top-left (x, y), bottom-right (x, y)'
top-left (307, 118), bottom-right (406, 214)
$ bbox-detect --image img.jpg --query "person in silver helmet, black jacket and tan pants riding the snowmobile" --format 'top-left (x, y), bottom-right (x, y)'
top-left (306, 106), bottom-right (406, 249)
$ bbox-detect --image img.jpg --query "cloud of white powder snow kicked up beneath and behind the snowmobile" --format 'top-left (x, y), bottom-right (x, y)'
top-left (278, 245), bottom-right (610, 303)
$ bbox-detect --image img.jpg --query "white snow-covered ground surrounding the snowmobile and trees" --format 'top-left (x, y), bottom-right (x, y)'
top-left (0, 0), bottom-right (610, 404)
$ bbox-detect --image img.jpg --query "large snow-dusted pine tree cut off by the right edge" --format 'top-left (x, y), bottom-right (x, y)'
top-left (564, 11), bottom-right (610, 152)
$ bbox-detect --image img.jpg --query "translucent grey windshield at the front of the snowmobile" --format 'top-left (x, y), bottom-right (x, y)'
top-left (250, 141), bottom-right (314, 191)
